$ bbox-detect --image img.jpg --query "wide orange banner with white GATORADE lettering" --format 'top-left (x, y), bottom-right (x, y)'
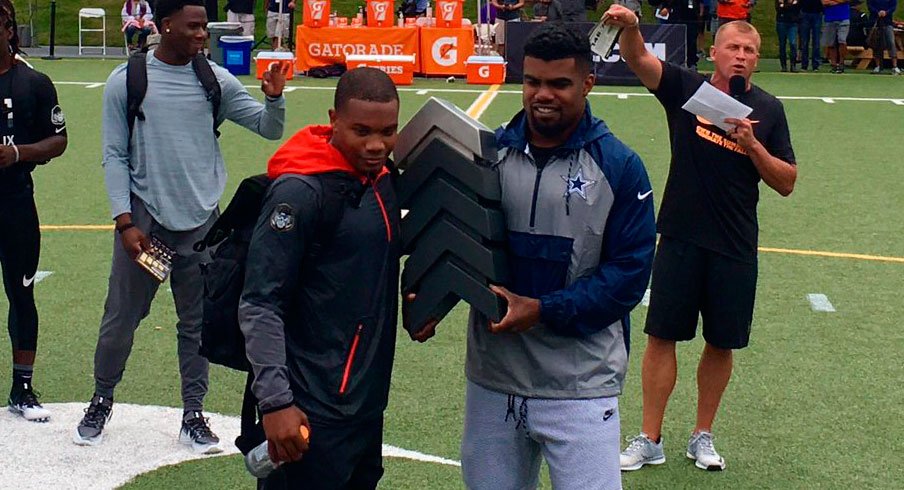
top-left (295, 25), bottom-right (422, 71)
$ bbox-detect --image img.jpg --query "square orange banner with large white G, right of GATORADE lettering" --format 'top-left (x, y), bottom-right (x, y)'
top-left (420, 26), bottom-right (474, 75)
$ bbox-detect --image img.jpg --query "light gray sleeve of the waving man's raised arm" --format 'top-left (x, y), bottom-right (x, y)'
top-left (213, 65), bottom-right (286, 140)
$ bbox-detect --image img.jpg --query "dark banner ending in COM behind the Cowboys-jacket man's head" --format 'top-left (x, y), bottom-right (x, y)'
top-left (505, 22), bottom-right (687, 85)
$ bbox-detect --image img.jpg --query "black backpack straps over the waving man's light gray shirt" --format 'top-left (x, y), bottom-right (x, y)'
top-left (126, 51), bottom-right (223, 144)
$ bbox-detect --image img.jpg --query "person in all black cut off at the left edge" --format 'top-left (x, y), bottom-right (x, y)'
top-left (0, 0), bottom-right (67, 421)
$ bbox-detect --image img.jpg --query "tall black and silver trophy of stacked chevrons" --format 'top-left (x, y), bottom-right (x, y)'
top-left (394, 98), bottom-right (508, 333)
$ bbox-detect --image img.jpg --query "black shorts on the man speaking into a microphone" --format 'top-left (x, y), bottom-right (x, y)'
top-left (644, 236), bottom-right (757, 349)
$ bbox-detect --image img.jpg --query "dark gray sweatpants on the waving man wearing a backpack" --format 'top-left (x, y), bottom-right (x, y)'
top-left (94, 196), bottom-right (219, 411)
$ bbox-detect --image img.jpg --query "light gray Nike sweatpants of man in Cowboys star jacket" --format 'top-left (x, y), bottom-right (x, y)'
top-left (461, 381), bottom-right (622, 490)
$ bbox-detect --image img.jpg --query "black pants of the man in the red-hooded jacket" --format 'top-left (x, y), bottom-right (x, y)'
top-left (257, 418), bottom-right (383, 490)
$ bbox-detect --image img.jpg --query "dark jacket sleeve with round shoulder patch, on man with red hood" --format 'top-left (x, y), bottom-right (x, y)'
top-left (239, 177), bottom-right (319, 413)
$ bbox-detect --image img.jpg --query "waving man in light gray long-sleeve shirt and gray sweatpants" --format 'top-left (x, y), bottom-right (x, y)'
top-left (74, 0), bottom-right (285, 453)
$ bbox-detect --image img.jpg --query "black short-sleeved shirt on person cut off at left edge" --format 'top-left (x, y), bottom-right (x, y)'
top-left (0, 62), bottom-right (66, 195)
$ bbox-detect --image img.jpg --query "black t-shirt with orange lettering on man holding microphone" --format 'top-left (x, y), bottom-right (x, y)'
top-left (653, 63), bottom-right (795, 262)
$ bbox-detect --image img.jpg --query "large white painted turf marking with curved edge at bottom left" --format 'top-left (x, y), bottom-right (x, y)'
top-left (0, 398), bottom-right (460, 490)
